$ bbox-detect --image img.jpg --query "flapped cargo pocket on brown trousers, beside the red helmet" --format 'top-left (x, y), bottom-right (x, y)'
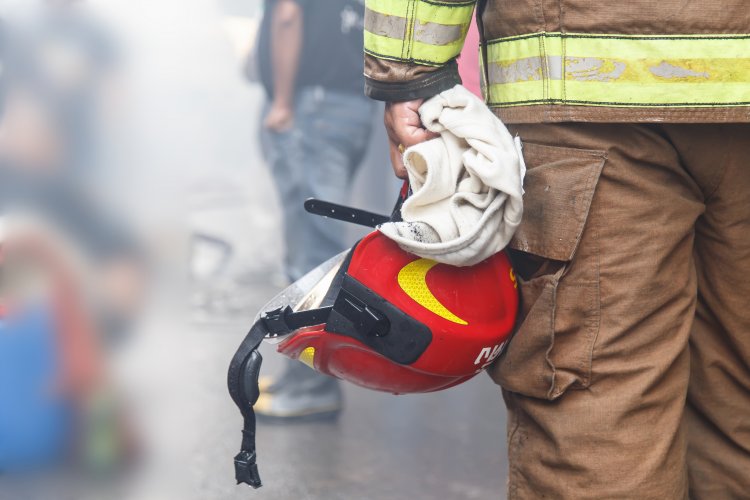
top-left (490, 143), bottom-right (606, 400)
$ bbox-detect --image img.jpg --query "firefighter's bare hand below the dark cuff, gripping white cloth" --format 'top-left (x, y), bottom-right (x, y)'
top-left (383, 99), bottom-right (438, 179)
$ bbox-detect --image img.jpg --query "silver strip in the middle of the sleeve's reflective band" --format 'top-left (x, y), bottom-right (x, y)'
top-left (365, 9), bottom-right (464, 45)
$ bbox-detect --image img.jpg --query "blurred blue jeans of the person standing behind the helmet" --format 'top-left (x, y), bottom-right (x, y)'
top-left (262, 87), bottom-right (375, 282)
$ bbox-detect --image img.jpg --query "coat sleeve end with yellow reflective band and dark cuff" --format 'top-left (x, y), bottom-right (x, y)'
top-left (364, 0), bottom-right (476, 101)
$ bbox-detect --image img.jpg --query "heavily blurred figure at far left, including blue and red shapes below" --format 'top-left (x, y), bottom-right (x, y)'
top-left (0, 3), bottom-right (145, 478)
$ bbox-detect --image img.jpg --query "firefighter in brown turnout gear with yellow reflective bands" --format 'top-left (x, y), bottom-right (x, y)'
top-left (364, 0), bottom-right (750, 499)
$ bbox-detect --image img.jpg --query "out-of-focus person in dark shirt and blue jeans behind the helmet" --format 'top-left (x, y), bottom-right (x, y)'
top-left (255, 0), bottom-right (375, 421)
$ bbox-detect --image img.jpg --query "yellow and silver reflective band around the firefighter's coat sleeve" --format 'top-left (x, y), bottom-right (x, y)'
top-left (365, 0), bottom-right (475, 66)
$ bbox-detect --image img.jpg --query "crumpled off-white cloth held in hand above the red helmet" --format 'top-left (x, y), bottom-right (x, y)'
top-left (379, 85), bottom-right (526, 266)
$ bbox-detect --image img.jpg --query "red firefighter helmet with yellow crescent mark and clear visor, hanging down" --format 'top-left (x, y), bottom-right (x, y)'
top-left (264, 231), bottom-right (518, 394)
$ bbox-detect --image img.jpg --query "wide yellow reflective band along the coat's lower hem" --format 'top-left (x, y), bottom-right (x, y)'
top-left (487, 33), bottom-right (750, 107)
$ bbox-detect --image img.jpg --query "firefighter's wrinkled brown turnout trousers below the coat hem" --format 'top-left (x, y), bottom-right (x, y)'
top-left (491, 124), bottom-right (750, 499)
